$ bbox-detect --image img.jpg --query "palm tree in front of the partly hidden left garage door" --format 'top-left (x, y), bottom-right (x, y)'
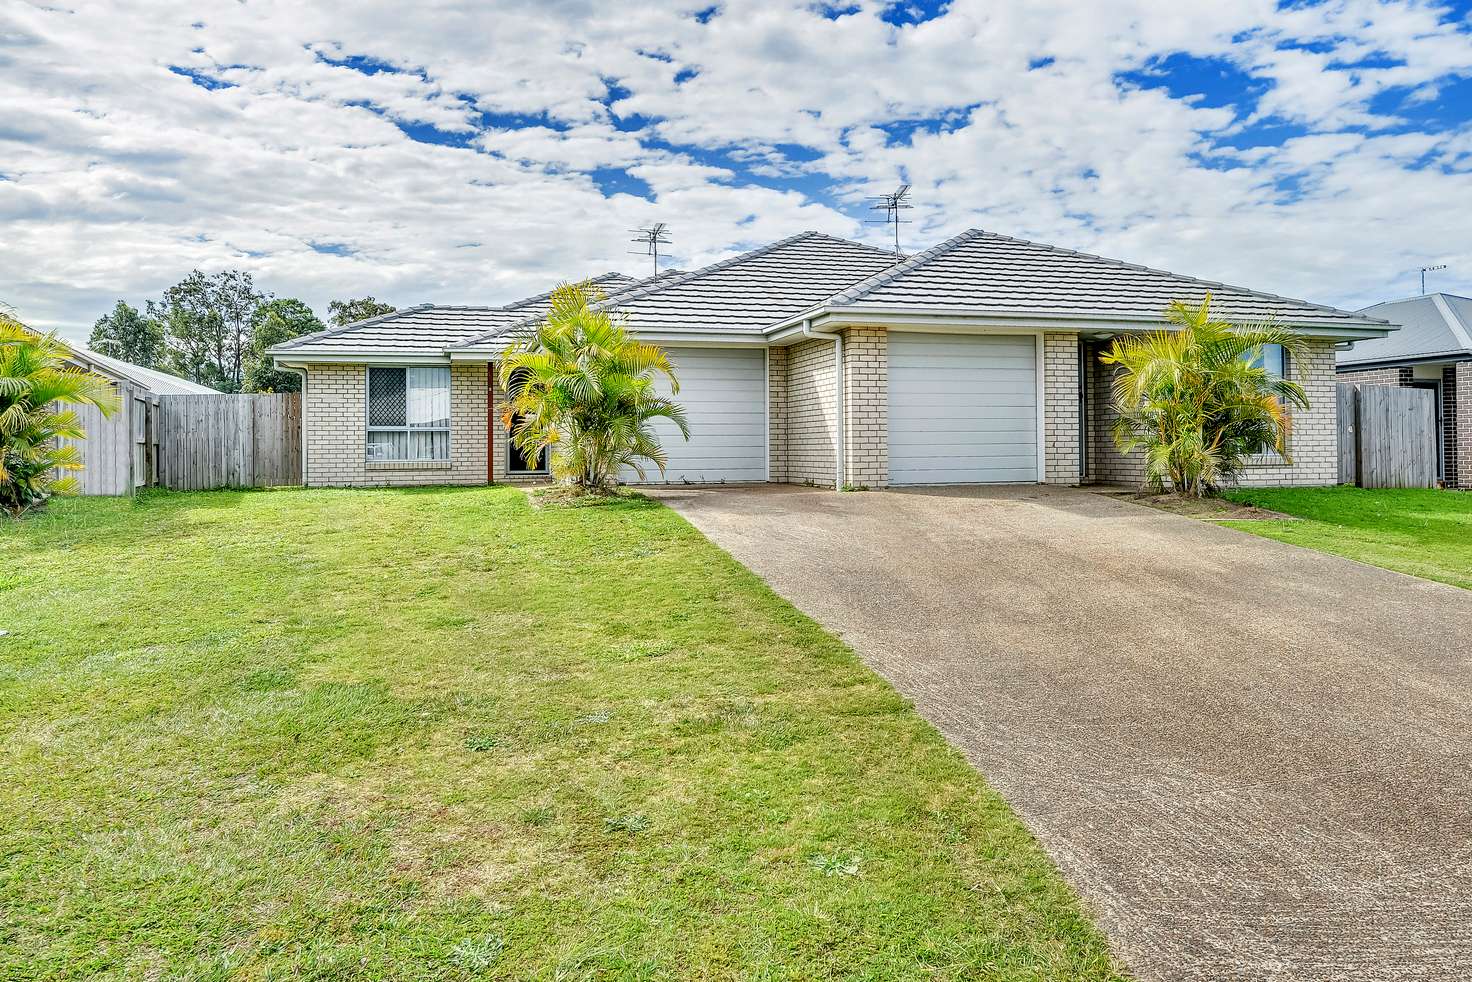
top-left (500, 283), bottom-right (690, 492)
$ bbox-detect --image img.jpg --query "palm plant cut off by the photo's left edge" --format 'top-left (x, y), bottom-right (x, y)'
top-left (0, 312), bottom-right (118, 518)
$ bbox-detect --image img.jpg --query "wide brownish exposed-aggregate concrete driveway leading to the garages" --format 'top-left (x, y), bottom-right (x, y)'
top-left (659, 486), bottom-right (1472, 979)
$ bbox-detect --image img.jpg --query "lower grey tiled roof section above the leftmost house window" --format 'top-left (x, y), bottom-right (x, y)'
top-left (271, 272), bottom-right (642, 356)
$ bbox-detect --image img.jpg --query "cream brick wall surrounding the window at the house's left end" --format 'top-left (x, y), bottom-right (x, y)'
top-left (302, 365), bottom-right (486, 487)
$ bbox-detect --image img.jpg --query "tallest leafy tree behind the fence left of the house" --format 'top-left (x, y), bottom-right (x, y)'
top-left (149, 269), bottom-right (266, 392)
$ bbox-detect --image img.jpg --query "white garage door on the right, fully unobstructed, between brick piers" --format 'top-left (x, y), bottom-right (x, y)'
top-left (889, 331), bottom-right (1038, 484)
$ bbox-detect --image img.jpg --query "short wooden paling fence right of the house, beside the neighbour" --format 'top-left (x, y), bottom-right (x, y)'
top-left (1338, 381), bottom-right (1438, 487)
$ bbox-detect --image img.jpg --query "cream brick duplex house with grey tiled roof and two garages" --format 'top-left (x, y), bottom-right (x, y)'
top-left (271, 230), bottom-right (1394, 487)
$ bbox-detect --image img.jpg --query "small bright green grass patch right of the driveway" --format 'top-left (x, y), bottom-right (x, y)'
top-left (1222, 487), bottom-right (1472, 589)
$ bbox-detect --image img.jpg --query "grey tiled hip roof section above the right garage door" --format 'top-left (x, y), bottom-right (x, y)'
top-left (829, 228), bottom-right (1376, 327)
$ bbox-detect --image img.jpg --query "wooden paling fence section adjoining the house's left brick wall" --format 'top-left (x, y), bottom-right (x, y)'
top-left (159, 392), bottom-right (302, 490)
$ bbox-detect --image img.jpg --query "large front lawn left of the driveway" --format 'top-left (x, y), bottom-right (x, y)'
top-left (0, 489), bottom-right (1119, 982)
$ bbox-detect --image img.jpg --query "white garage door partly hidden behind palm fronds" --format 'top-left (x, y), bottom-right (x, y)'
top-left (620, 347), bottom-right (767, 484)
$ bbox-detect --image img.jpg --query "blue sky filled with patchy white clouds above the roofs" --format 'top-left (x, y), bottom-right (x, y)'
top-left (0, 0), bottom-right (1472, 345)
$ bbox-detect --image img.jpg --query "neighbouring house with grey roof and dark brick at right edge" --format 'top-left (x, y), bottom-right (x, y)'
top-left (1338, 293), bottom-right (1472, 489)
